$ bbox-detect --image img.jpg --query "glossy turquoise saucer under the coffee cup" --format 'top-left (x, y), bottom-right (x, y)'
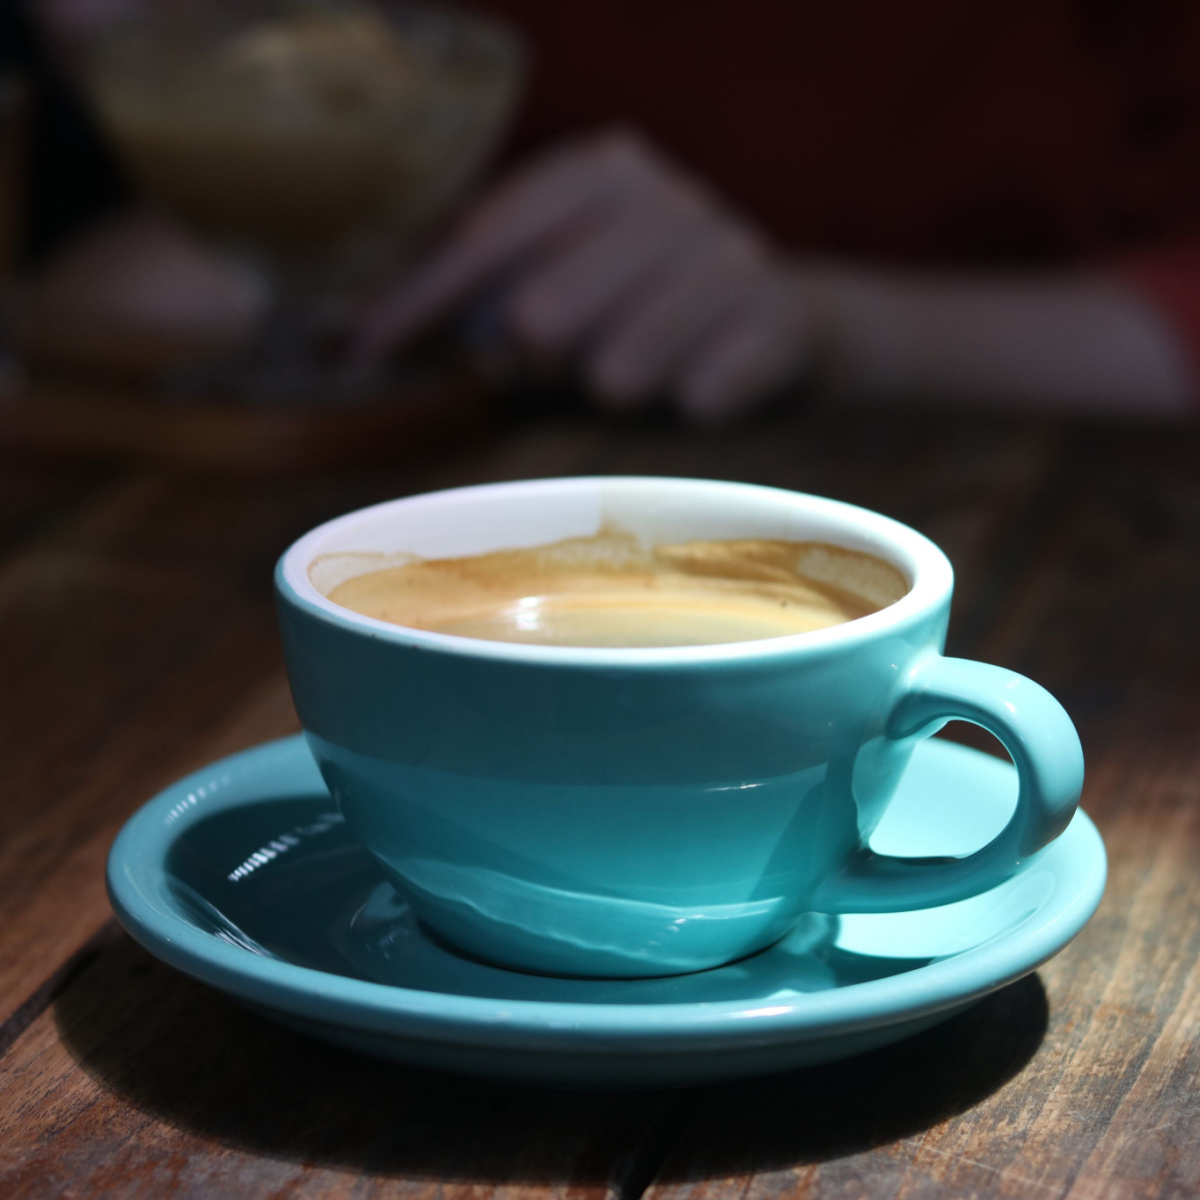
top-left (108, 737), bottom-right (1105, 1087)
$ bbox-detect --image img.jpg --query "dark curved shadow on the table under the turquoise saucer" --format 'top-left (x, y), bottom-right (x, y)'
top-left (44, 937), bottom-right (1048, 1180)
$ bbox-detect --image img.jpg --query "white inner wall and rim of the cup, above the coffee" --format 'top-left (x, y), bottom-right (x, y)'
top-left (281, 476), bottom-right (953, 656)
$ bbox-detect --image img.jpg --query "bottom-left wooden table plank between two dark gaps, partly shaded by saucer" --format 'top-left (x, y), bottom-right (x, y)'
top-left (0, 938), bottom-right (670, 1200)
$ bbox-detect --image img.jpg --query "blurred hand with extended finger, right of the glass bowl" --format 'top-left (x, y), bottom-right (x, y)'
top-left (358, 133), bottom-right (809, 420)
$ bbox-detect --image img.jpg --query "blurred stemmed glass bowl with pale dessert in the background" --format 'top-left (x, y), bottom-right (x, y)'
top-left (75, 0), bottom-right (524, 391)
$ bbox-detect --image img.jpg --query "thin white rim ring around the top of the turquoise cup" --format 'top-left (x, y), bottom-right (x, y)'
top-left (276, 475), bottom-right (954, 668)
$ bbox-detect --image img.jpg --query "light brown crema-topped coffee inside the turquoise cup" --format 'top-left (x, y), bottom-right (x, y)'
top-left (328, 530), bottom-right (908, 647)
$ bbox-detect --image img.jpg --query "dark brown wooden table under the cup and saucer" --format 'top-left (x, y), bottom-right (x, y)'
top-left (0, 405), bottom-right (1200, 1200)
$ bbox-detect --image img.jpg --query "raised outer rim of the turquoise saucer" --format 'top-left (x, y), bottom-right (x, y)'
top-left (107, 734), bottom-right (1106, 1051)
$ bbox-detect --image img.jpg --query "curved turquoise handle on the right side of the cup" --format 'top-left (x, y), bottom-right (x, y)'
top-left (810, 654), bottom-right (1084, 913)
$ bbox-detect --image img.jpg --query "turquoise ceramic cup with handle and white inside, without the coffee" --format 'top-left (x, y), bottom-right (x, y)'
top-left (276, 479), bottom-right (1084, 977)
